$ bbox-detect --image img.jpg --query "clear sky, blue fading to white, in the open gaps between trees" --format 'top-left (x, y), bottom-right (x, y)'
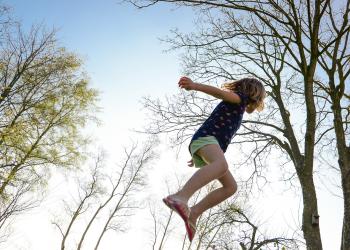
top-left (2, 0), bottom-right (341, 250)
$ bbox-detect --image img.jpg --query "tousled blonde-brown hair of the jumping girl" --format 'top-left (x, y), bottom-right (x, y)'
top-left (222, 78), bottom-right (266, 111)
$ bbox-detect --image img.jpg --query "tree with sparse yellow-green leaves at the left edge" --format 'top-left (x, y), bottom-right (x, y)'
top-left (0, 9), bottom-right (98, 242)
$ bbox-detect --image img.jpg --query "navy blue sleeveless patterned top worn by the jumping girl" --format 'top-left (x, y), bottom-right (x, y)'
top-left (191, 92), bottom-right (248, 152)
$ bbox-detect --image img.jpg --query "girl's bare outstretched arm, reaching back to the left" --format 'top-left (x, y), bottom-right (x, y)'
top-left (179, 77), bottom-right (241, 103)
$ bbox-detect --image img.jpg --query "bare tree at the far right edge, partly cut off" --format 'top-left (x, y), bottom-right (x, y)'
top-left (316, 1), bottom-right (350, 249)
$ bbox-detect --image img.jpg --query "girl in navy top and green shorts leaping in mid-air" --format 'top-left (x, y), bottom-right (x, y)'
top-left (163, 77), bottom-right (266, 241)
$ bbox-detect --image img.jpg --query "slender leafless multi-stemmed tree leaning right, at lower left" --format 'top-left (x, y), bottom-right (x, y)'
top-left (53, 140), bottom-right (156, 250)
